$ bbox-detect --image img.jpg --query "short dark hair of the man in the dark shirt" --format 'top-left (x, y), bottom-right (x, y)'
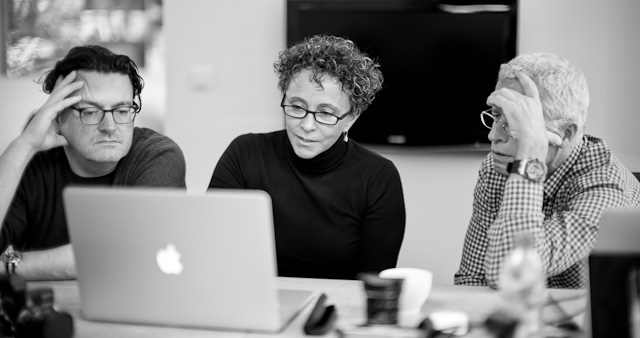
top-left (42, 45), bottom-right (144, 107)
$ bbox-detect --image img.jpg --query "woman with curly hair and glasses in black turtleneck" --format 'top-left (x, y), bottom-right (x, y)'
top-left (209, 35), bottom-right (405, 279)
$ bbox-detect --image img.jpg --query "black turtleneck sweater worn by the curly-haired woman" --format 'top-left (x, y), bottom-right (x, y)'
top-left (209, 131), bottom-right (405, 279)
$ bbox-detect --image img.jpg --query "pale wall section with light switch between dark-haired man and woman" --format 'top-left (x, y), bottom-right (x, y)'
top-left (164, 0), bottom-right (285, 191)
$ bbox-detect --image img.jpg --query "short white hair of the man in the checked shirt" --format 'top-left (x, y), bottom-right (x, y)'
top-left (498, 53), bottom-right (589, 132)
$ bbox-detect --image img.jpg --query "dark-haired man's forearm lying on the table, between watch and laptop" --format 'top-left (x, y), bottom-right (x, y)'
top-left (16, 244), bottom-right (76, 280)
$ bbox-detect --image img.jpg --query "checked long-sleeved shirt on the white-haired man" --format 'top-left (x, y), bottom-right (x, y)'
top-left (454, 135), bottom-right (640, 288)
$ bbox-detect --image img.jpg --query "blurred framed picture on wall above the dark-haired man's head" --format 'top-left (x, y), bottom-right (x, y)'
top-left (0, 0), bottom-right (162, 78)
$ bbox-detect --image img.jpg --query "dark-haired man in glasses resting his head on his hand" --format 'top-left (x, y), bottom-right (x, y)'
top-left (0, 46), bottom-right (186, 279)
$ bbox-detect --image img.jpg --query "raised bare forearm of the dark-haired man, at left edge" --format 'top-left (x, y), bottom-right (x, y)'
top-left (0, 138), bottom-right (35, 226)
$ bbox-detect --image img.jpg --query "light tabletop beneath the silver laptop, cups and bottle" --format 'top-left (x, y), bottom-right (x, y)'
top-left (28, 277), bottom-right (587, 338)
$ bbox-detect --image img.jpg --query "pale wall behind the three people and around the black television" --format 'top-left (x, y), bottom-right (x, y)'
top-left (0, 0), bottom-right (640, 285)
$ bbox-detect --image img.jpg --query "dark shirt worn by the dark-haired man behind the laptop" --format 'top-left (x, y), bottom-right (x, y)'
top-left (0, 127), bottom-right (186, 252)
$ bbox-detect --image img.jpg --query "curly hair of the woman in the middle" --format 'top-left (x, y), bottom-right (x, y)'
top-left (273, 35), bottom-right (384, 115)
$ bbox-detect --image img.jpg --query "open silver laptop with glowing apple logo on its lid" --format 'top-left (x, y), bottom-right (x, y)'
top-left (63, 187), bottom-right (315, 333)
